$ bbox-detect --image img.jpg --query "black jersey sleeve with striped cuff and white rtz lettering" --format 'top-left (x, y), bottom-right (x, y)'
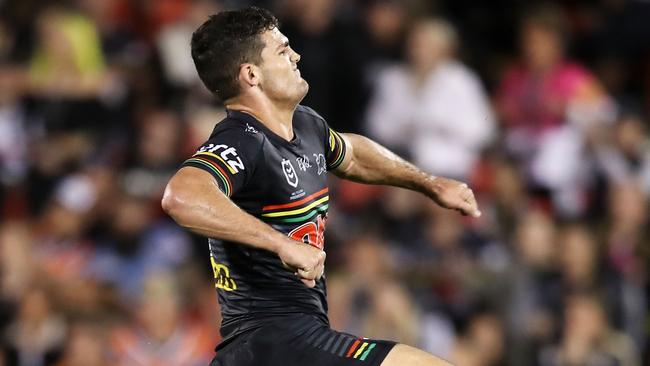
top-left (181, 130), bottom-right (261, 197)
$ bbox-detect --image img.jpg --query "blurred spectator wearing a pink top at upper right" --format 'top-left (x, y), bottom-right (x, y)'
top-left (496, 8), bottom-right (615, 216)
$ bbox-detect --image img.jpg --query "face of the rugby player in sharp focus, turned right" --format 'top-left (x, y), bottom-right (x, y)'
top-left (260, 28), bottom-right (309, 104)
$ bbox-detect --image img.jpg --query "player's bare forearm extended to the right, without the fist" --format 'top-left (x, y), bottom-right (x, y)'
top-left (335, 134), bottom-right (435, 196)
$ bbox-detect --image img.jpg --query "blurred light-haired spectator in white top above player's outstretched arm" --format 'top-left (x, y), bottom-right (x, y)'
top-left (366, 19), bottom-right (494, 179)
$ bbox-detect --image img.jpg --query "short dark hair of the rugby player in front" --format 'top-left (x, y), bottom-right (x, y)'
top-left (192, 6), bottom-right (279, 101)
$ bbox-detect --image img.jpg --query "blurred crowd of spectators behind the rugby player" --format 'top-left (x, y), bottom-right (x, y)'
top-left (0, 0), bottom-right (650, 366)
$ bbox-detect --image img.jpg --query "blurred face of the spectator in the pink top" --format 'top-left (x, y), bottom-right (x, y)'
top-left (521, 22), bottom-right (562, 72)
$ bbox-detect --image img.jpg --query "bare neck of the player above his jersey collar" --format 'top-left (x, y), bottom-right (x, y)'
top-left (226, 100), bottom-right (296, 141)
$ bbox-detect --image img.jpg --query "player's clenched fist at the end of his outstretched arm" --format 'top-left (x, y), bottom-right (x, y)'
top-left (428, 177), bottom-right (481, 217)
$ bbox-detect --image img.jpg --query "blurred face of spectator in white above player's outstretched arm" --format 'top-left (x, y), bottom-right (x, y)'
top-left (406, 20), bottom-right (455, 73)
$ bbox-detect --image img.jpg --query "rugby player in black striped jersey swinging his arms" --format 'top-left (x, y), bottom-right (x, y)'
top-left (162, 7), bottom-right (481, 366)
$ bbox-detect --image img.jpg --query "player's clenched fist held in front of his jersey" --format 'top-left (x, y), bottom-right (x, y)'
top-left (278, 239), bottom-right (326, 287)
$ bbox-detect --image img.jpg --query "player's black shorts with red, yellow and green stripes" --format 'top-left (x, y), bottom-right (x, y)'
top-left (210, 315), bottom-right (395, 366)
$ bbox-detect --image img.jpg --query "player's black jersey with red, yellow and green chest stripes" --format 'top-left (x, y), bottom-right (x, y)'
top-left (183, 106), bottom-right (345, 341)
